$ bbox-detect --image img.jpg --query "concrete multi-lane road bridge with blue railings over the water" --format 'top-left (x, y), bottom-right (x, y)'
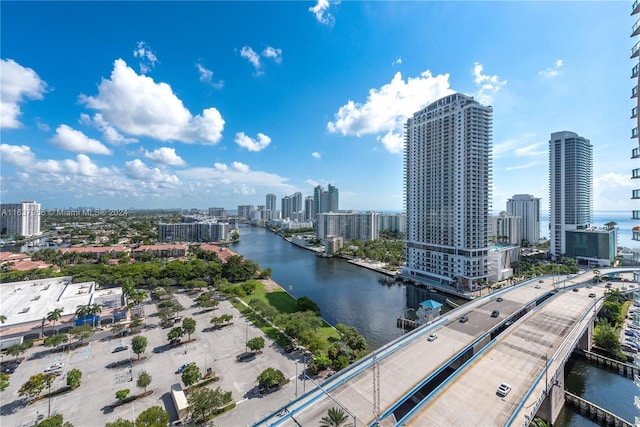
top-left (254, 268), bottom-right (638, 427)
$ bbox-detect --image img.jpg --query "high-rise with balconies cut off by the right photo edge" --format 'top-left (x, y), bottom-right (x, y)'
top-left (631, 0), bottom-right (640, 256)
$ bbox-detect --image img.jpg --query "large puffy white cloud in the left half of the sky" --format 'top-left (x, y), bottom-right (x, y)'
top-left (80, 59), bottom-right (225, 144)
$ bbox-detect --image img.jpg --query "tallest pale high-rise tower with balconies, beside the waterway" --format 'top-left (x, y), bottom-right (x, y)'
top-left (402, 93), bottom-right (493, 290)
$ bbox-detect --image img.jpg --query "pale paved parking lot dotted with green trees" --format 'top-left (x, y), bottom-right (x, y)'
top-left (0, 293), bottom-right (310, 427)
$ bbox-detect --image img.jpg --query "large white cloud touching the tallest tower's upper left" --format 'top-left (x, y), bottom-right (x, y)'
top-left (327, 71), bottom-right (453, 153)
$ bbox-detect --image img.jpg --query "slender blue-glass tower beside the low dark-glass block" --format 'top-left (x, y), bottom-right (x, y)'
top-left (549, 131), bottom-right (593, 260)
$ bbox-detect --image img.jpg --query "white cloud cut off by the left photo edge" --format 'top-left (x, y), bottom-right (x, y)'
top-left (0, 59), bottom-right (47, 129)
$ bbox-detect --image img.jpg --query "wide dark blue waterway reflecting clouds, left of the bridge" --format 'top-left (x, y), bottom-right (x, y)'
top-left (230, 226), bottom-right (463, 349)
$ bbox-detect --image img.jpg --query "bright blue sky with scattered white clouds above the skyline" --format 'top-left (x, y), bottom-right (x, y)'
top-left (0, 0), bottom-right (637, 211)
